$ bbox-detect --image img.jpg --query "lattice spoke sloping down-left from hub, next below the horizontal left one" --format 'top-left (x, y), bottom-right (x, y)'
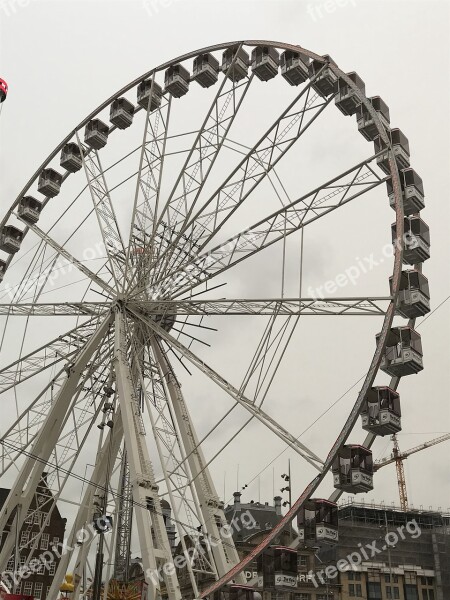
top-left (0, 318), bottom-right (102, 394)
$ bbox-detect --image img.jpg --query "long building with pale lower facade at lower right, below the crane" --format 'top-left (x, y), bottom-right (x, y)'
top-left (316, 503), bottom-right (450, 600)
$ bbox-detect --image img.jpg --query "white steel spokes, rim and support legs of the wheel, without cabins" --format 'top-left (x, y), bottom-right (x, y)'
top-left (0, 40), bottom-right (428, 600)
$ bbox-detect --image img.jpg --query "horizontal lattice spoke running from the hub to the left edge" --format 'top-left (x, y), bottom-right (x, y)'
top-left (0, 302), bottom-right (111, 317)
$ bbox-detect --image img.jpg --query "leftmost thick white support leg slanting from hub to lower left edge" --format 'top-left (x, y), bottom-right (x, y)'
top-left (0, 316), bottom-right (112, 572)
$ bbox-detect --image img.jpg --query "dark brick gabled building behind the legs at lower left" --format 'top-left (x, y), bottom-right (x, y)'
top-left (0, 473), bottom-right (66, 600)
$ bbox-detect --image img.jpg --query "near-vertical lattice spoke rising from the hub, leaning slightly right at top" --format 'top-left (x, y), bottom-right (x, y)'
top-left (125, 94), bottom-right (172, 285)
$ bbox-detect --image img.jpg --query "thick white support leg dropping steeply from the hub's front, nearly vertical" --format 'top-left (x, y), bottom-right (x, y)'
top-left (114, 310), bottom-right (181, 600)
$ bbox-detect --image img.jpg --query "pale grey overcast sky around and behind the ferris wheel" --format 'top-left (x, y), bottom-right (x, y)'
top-left (0, 0), bottom-right (450, 564)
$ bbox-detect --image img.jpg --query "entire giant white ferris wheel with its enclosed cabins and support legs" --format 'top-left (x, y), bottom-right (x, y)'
top-left (0, 40), bottom-right (430, 600)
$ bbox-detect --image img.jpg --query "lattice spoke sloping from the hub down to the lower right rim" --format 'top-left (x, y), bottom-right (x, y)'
top-left (130, 312), bottom-right (322, 471)
